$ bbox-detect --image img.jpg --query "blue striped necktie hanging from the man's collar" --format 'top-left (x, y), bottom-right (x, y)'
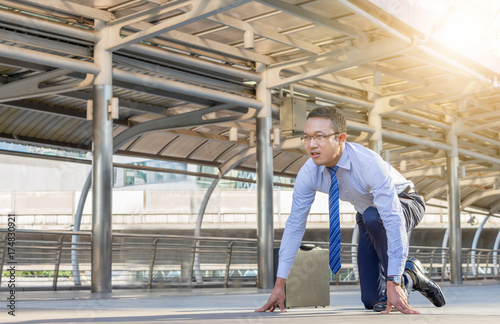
top-left (327, 166), bottom-right (340, 273)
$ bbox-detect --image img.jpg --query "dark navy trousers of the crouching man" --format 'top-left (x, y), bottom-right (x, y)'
top-left (356, 192), bottom-right (425, 309)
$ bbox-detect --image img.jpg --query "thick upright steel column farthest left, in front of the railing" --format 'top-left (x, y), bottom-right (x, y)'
top-left (91, 20), bottom-right (113, 293)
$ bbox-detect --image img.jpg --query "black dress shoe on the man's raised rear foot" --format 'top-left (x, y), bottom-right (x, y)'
top-left (405, 258), bottom-right (446, 307)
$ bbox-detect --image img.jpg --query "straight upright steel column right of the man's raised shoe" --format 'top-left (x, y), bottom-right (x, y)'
top-left (446, 124), bottom-right (463, 284)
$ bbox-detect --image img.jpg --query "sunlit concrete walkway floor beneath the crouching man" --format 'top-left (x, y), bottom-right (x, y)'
top-left (0, 281), bottom-right (500, 324)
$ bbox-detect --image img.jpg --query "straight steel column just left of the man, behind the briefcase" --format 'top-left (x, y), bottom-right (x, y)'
top-left (256, 63), bottom-right (274, 288)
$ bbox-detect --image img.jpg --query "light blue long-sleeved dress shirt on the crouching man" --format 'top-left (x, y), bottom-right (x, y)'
top-left (277, 142), bottom-right (413, 279)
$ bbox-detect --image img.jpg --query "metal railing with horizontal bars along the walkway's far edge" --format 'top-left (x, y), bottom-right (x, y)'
top-left (0, 229), bottom-right (500, 290)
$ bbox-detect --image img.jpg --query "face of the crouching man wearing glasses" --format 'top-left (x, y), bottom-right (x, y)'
top-left (304, 117), bottom-right (346, 167)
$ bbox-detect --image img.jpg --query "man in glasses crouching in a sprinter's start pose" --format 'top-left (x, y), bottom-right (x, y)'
top-left (256, 107), bottom-right (445, 314)
